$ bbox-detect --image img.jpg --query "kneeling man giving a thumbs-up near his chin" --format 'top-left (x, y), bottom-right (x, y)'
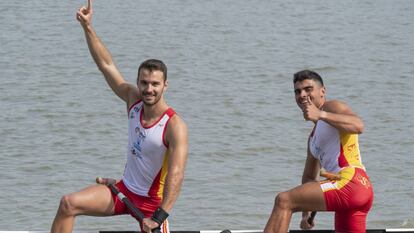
top-left (264, 70), bottom-right (373, 233)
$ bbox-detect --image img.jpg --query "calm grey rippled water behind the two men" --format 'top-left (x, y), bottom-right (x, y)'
top-left (0, 0), bottom-right (414, 230)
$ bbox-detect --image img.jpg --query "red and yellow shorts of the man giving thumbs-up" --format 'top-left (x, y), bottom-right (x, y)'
top-left (320, 167), bottom-right (374, 233)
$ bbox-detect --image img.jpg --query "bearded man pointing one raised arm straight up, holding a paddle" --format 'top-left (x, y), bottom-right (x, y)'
top-left (51, 0), bottom-right (188, 233)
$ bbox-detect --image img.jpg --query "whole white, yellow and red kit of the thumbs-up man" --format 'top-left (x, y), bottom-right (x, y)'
top-left (309, 121), bottom-right (374, 233)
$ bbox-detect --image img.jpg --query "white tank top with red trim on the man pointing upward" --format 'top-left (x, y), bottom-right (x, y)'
top-left (122, 101), bottom-right (175, 198)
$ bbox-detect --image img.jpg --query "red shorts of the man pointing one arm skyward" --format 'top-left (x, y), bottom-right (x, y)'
top-left (111, 180), bottom-right (169, 233)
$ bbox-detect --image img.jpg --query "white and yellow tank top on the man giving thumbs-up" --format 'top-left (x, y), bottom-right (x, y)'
top-left (309, 120), bottom-right (365, 173)
